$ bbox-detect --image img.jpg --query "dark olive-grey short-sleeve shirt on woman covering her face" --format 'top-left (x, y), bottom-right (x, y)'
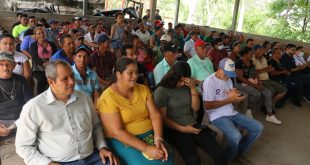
top-left (154, 86), bottom-right (195, 126)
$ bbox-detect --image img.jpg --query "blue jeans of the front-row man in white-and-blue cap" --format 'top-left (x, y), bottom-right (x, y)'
top-left (211, 113), bottom-right (263, 159)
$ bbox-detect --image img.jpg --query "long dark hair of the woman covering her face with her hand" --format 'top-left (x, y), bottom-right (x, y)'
top-left (158, 62), bottom-right (191, 88)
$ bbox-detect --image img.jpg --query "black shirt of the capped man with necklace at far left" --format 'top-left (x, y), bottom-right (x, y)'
top-left (0, 74), bottom-right (32, 120)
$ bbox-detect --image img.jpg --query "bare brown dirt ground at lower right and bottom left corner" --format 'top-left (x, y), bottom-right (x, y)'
top-left (0, 102), bottom-right (310, 165)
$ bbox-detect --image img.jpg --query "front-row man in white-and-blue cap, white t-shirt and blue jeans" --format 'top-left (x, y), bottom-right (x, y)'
top-left (203, 58), bottom-right (263, 164)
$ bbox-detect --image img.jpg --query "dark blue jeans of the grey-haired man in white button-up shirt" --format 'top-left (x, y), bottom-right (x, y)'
top-left (59, 150), bottom-right (110, 165)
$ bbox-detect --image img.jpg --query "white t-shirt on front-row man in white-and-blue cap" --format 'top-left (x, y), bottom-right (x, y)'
top-left (203, 73), bottom-right (237, 121)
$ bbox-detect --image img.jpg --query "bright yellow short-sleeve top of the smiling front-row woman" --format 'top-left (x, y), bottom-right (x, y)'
top-left (97, 84), bottom-right (152, 137)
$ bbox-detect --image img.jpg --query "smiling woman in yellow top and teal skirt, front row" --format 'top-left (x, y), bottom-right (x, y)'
top-left (97, 58), bottom-right (173, 165)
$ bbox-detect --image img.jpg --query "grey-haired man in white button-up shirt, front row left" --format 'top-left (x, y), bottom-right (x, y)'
top-left (15, 60), bottom-right (118, 165)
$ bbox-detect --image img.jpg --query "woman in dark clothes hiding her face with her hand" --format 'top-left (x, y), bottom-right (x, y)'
top-left (154, 62), bottom-right (227, 165)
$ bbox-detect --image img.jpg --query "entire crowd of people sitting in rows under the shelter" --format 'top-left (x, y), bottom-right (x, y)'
top-left (0, 10), bottom-right (310, 165)
